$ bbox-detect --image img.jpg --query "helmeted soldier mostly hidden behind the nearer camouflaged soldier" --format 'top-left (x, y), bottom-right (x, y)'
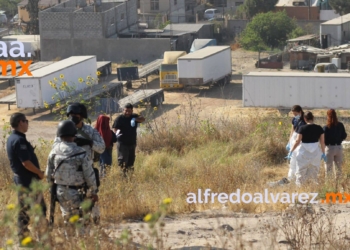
top-left (53, 103), bottom-right (106, 224)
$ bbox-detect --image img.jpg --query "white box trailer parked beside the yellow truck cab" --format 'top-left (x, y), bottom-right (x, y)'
top-left (177, 46), bottom-right (232, 86)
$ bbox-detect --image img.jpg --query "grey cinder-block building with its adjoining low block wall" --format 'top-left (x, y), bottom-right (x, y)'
top-left (39, 0), bottom-right (170, 63)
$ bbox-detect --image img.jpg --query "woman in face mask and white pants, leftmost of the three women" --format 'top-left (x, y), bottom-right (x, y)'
top-left (286, 105), bottom-right (306, 182)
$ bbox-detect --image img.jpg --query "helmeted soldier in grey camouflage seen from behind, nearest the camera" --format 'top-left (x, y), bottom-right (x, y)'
top-left (46, 120), bottom-right (98, 236)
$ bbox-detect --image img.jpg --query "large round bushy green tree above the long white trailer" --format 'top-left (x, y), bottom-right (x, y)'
top-left (239, 11), bottom-right (300, 51)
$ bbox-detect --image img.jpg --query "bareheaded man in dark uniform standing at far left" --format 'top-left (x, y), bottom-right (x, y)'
top-left (6, 113), bottom-right (46, 240)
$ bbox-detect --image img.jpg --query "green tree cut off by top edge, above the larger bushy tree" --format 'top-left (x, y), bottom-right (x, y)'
top-left (237, 0), bottom-right (278, 19)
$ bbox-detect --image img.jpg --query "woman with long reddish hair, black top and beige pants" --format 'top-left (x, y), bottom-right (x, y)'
top-left (323, 109), bottom-right (348, 180)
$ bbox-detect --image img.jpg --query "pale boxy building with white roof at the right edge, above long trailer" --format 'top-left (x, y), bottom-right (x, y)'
top-left (320, 14), bottom-right (350, 48)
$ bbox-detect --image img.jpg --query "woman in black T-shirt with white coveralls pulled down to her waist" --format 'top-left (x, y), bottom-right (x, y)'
top-left (287, 112), bottom-right (327, 186)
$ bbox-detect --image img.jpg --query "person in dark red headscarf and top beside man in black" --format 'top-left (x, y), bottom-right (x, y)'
top-left (95, 115), bottom-right (117, 177)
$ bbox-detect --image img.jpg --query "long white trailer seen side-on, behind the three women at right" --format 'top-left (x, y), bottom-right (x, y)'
top-left (243, 72), bottom-right (350, 109)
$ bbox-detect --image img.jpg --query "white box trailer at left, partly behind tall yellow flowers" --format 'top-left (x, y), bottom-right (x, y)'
top-left (15, 56), bottom-right (97, 108)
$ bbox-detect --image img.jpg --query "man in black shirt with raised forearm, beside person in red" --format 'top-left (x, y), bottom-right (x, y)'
top-left (112, 103), bottom-right (145, 176)
